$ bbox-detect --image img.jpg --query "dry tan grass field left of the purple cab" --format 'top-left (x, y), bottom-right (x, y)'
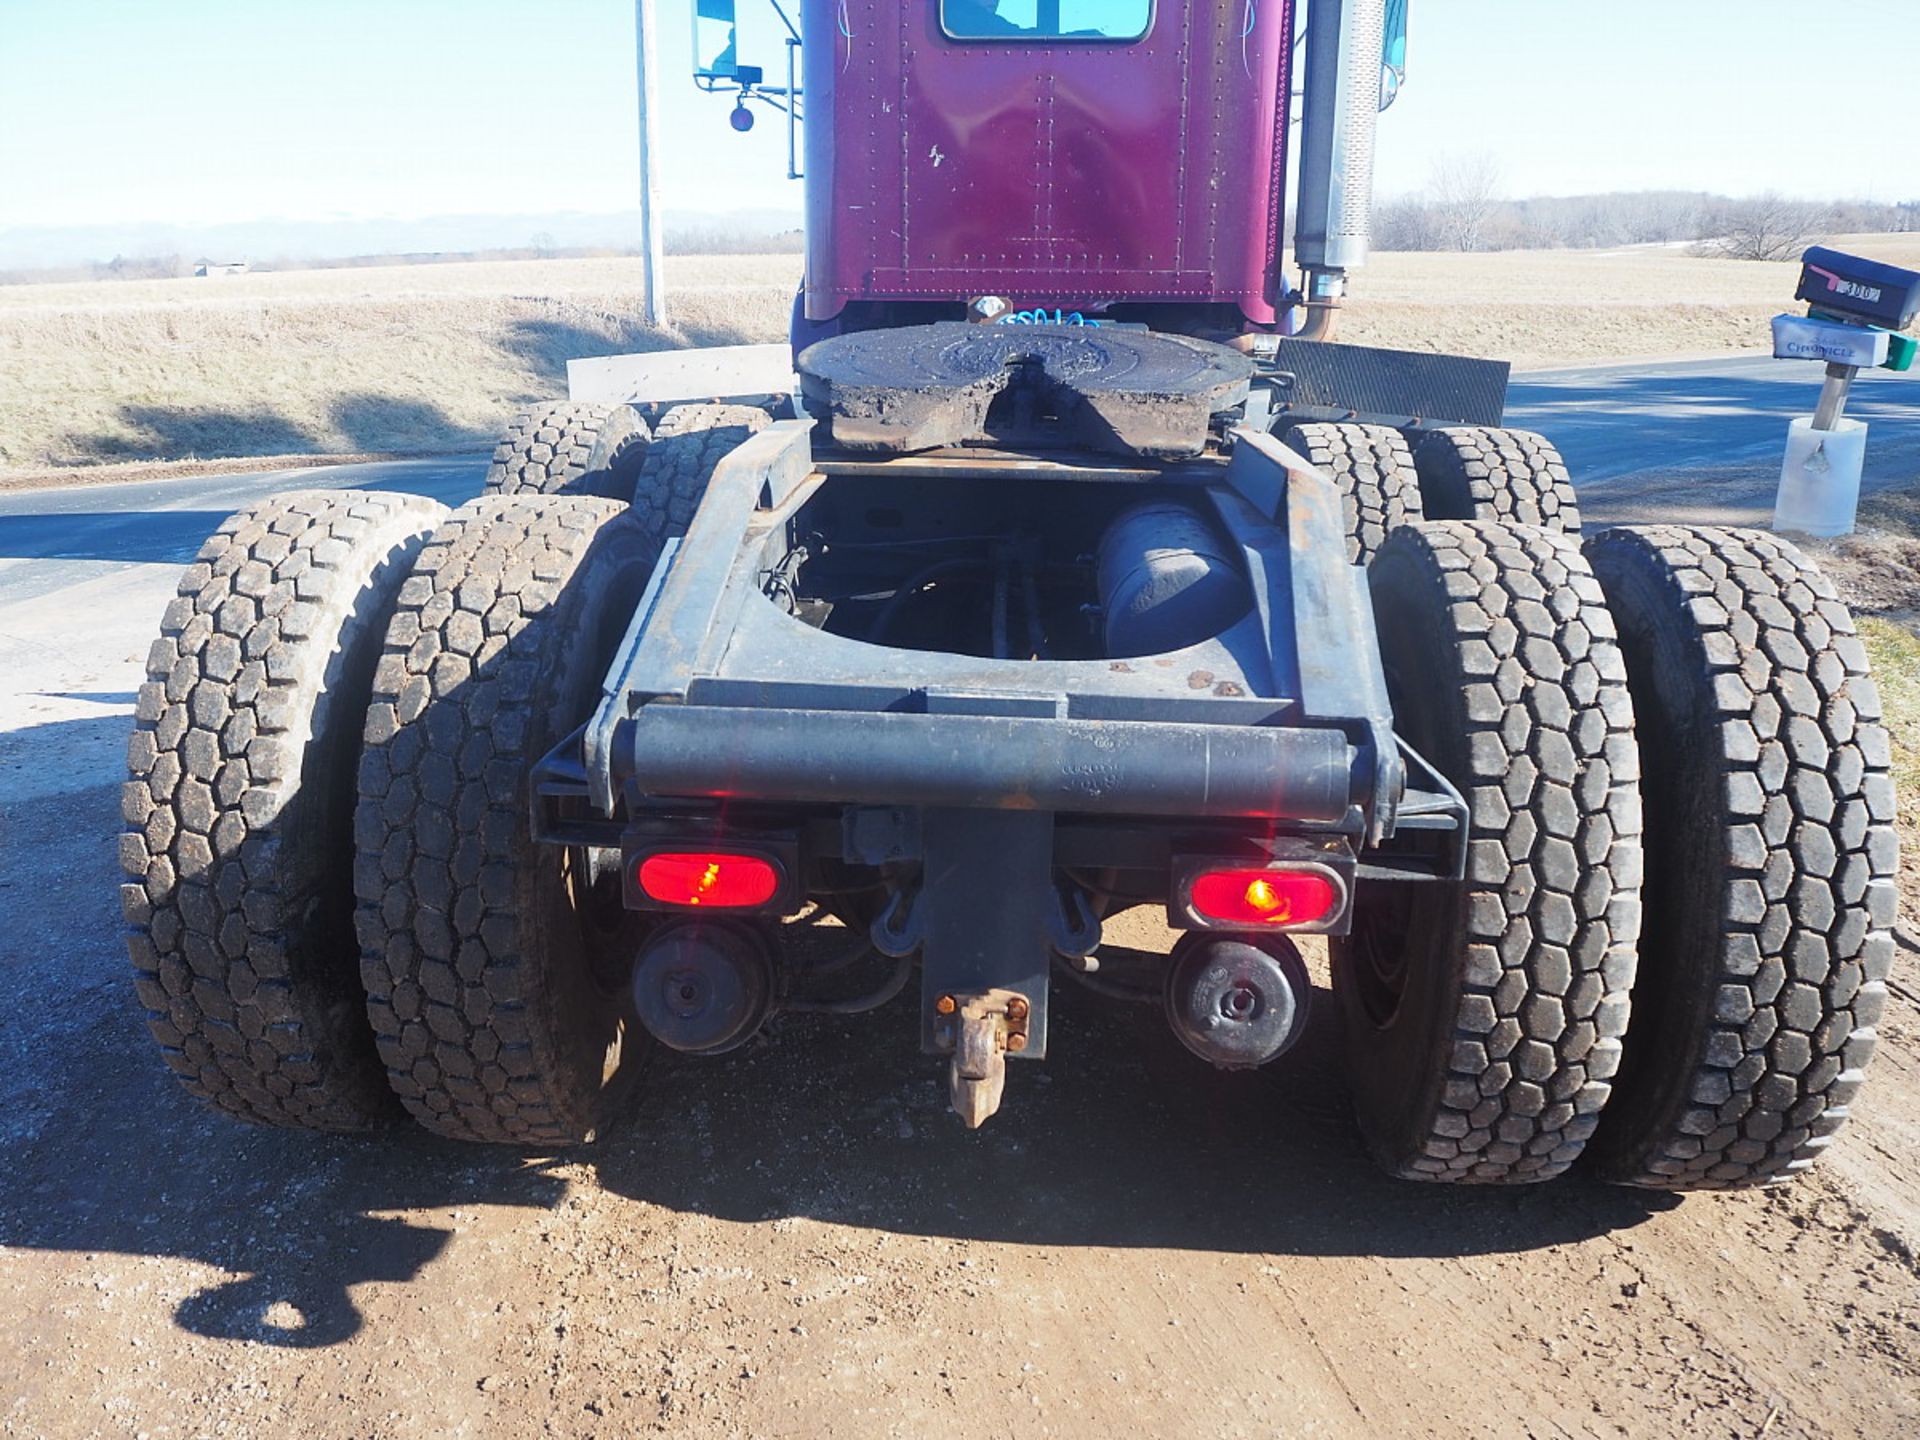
top-left (0, 255), bottom-right (801, 472)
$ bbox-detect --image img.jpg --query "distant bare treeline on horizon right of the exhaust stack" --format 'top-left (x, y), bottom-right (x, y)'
top-left (1373, 180), bottom-right (1920, 259)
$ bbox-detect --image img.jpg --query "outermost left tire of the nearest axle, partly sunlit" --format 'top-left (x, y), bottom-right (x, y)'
top-left (121, 490), bottom-right (445, 1131)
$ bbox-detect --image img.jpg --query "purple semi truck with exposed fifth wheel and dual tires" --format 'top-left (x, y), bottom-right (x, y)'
top-left (121, 0), bottom-right (1897, 1188)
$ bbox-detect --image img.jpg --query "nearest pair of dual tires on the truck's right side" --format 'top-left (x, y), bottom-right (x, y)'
top-left (1334, 520), bottom-right (1897, 1188)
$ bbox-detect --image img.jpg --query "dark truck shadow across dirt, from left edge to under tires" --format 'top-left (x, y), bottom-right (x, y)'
top-left (0, 733), bottom-right (1670, 1348)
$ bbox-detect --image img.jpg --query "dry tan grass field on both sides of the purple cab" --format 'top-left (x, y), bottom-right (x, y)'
top-left (0, 234), bottom-right (1920, 474)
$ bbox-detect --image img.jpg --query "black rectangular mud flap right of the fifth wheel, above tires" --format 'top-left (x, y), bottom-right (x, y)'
top-left (1273, 340), bottom-right (1513, 428)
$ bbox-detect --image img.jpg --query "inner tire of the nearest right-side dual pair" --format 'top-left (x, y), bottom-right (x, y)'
top-left (1332, 520), bottom-right (1640, 1183)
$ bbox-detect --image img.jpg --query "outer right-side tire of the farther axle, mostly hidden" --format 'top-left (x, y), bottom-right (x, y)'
top-left (1413, 424), bottom-right (1580, 536)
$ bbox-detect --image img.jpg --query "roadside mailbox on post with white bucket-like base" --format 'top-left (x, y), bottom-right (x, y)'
top-left (1774, 246), bottom-right (1920, 536)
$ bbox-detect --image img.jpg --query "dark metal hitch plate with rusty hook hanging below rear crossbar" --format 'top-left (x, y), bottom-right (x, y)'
top-left (914, 808), bottom-right (1060, 1129)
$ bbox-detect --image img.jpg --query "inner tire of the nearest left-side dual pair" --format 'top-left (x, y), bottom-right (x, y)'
top-left (353, 495), bottom-right (655, 1144)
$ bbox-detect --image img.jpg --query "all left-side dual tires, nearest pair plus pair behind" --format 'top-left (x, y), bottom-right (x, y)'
top-left (121, 403), bottom-right (768, 1144)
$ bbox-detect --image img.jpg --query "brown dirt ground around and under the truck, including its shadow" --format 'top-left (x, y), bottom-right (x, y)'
top-left (0, 445), bottom-right (1920, 1440)
